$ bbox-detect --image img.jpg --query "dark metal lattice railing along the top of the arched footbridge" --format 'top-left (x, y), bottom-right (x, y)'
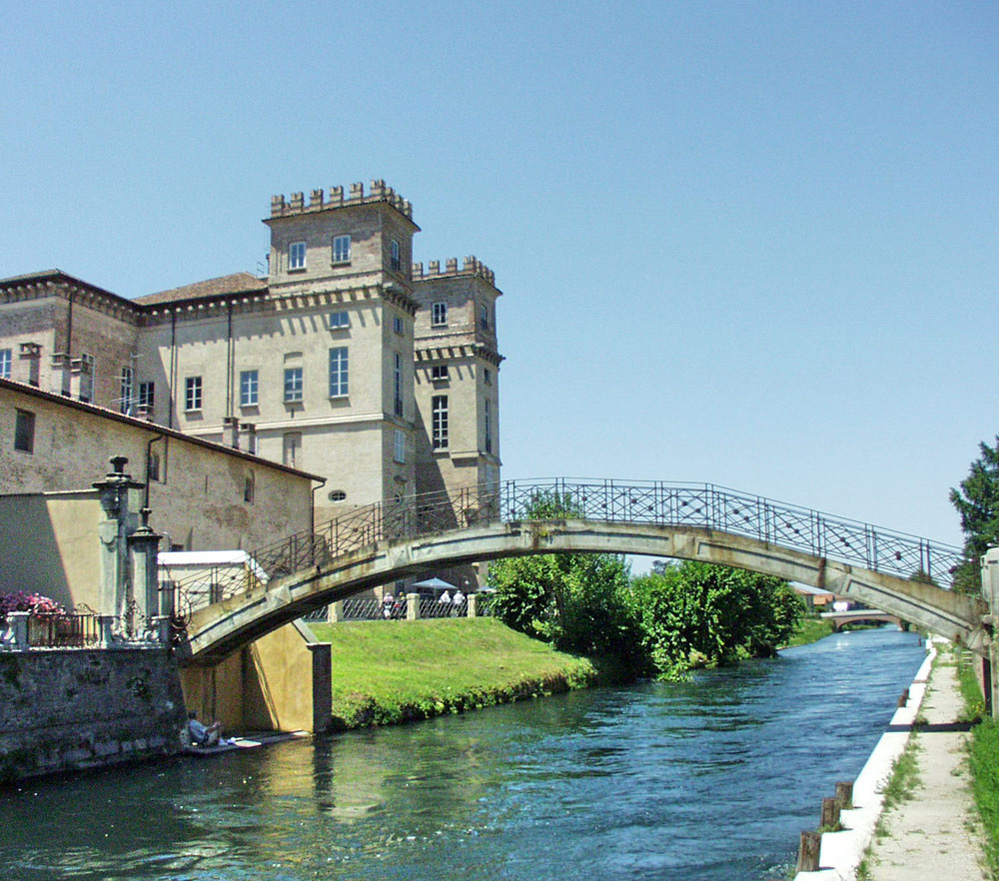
top-left (171, 478), bottom-right (962, 615)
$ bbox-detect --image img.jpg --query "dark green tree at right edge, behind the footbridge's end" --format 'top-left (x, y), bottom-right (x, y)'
top-left (950, 436), bottom-right (999, 593)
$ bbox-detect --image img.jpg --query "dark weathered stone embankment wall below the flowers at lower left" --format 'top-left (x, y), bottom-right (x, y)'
top-left (0, 648), bottom-right (186, 783)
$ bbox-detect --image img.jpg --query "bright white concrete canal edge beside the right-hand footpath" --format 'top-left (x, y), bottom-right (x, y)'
top-left (795, 641), bottom-right (936, 881)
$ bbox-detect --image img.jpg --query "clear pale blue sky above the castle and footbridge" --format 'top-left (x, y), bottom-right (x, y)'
top-left (0, 0), bottom-right (999, 543)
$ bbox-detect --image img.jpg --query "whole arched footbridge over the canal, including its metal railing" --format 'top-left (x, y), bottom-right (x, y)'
top-left (170, 479), bottom-right (987, 664)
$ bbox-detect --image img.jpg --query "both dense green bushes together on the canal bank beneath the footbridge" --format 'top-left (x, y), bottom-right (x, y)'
top-left (489, 554), bottom-right (804, 679)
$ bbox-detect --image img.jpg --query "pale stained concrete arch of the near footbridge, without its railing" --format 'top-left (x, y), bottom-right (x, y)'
top-left (181, 517), bottom-right (987, 665)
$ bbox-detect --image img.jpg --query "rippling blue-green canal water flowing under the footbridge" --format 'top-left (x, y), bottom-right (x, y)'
top-left (0, 630), bottom-right (924, 881)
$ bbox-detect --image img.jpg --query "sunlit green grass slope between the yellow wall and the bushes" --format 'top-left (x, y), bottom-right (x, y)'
top-left (311, 618), bottom-right (600, 730)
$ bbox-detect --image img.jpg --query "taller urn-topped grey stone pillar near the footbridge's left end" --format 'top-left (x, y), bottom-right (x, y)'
top-left (94, 456), bottom-right (143, 617)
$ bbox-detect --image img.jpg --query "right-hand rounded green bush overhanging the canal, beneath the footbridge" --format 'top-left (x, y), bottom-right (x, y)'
top-left (629, 562), bottom-right (804, 679)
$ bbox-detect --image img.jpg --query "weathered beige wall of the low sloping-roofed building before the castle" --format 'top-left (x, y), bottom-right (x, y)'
top-left (0, 381), bottom-right (314, 550)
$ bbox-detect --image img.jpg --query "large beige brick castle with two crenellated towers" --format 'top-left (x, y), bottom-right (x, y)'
top-left (0, 181), bottom-right (502, 583)
